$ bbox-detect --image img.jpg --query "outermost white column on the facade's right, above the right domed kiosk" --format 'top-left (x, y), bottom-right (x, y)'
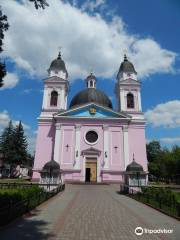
top-left (123, 125), bottom-right (129, 170)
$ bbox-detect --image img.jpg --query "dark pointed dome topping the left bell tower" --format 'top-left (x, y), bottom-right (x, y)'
top-left (48, 53), bottom-right (68, 78)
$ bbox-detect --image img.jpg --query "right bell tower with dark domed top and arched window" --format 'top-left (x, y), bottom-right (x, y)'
top-left (115, 55), bottom-right (142, 115)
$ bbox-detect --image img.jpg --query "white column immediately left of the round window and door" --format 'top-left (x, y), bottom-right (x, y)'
top-left (73, 124), bottom-right (81, 169)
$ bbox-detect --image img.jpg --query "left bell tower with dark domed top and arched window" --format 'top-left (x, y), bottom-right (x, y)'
top-left (42, 53), bottom-right (69, 115)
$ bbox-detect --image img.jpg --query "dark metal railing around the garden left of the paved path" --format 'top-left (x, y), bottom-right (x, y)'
top-left (0, 183), bottom-right (65, 226)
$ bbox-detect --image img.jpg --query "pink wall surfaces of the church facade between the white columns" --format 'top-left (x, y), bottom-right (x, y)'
top-left (33, 116), bottom-right (147, 181)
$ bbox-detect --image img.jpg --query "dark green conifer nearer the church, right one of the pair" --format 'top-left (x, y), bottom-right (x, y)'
top-left (13, 121), bottom-right (28, 164)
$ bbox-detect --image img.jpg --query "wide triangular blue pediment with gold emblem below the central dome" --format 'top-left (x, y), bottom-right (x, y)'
top-left (54, 103), bottom-right (131, 119)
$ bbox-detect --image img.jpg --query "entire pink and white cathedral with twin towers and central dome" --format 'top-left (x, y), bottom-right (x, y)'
top-left (33, 53), bottom-right (147, 183)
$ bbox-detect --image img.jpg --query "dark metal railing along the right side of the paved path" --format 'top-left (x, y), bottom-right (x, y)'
top-left (120, 185), bottom-right (180, 219)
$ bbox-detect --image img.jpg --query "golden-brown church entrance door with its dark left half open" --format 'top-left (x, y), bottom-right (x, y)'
top-left (85, 158), bottom-right (97, 182)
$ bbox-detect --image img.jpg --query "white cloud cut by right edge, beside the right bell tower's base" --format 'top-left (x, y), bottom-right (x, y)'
top-left (145, 100), bottom-right (180, 128)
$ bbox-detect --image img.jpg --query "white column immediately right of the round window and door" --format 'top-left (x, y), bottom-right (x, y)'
top-left (103, 125), bottom-right (110, 169)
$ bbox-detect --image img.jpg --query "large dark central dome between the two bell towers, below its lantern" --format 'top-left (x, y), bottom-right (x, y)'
top-left (70, 88), bottom-right (112, 108)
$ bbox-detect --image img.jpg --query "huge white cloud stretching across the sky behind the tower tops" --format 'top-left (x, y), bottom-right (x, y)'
top-left (2, 0), bottom-right (176, 79)
